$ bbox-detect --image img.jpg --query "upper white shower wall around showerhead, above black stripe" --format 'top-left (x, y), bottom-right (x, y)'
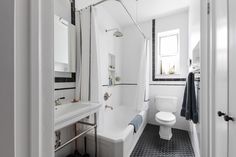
top-left (96, 6), bottom-right (123, 85)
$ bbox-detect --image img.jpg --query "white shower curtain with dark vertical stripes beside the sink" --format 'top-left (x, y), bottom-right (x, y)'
top-left (76, 7), bottom-right (101, 102)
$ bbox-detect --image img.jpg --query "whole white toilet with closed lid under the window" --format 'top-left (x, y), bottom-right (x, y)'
top-left (155, 97), bottom-right (177, 140)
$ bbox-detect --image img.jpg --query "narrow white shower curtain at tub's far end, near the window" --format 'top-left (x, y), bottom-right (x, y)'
top-left (136, 39), bottom-right (150, 111)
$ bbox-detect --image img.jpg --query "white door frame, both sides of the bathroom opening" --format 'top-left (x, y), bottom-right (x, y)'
top-left (30, 0), bottom-right (213, 157)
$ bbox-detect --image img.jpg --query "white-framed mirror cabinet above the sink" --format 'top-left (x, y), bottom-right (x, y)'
top-left (54, 15), bottom-right (76, 72)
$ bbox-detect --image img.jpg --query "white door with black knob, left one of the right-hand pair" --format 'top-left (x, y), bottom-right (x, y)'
top-left (212, 0), bottom-right (229, 157)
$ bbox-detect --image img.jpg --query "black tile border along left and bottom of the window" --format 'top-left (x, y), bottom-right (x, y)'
top-left (152, 19), bottom-right (186, 81)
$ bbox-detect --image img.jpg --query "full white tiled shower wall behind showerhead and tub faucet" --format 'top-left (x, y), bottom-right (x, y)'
top-left (96, 7), bottom-right (123, 123)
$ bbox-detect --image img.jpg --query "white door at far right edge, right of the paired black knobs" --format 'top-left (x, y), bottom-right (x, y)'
top-left (228, 0), bottom-right (236, 157)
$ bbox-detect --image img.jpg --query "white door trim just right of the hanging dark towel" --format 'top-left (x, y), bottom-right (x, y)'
top-left (200, 0), bottom-right (211, 157)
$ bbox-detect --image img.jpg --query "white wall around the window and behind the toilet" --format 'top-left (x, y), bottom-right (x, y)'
top-left (148, 11), bottom-right (189, 130)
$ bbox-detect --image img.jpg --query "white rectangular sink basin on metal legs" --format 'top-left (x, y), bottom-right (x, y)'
top-left (54, 102), bottom-right (101, 131)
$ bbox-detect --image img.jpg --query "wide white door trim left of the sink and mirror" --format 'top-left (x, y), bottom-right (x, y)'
top-left (30, 0), bottom-right (54, 157)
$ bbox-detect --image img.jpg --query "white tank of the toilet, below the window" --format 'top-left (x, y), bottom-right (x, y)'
top-left (155, 96), bottom-right (178, 112)
